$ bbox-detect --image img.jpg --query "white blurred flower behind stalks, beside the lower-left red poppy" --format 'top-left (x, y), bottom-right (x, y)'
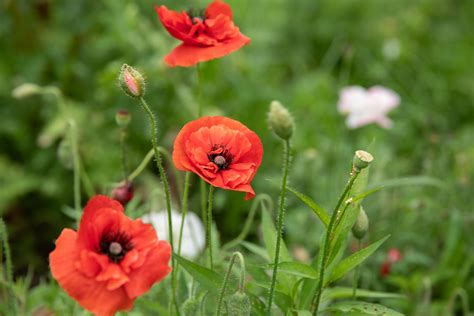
top-left (142, 210), bottom-right (206, 259)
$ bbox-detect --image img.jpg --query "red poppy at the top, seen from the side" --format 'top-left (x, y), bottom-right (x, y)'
top-left (155, 0), bottom-right (250, 67)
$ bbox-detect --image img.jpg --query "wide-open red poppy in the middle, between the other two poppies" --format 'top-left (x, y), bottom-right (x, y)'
top-left (173, 116), bottom-right (263, 200)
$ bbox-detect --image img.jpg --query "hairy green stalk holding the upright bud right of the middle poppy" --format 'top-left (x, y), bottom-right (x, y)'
top-left (267, 140), bottom-right (291, 315)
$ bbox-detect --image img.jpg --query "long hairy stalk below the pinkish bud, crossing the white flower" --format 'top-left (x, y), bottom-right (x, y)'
top-left (140, 98), bottom-right (179, 315)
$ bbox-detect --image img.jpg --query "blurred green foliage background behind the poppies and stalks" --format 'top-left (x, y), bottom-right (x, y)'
top-left (0, 0), bottom-right (474, 315)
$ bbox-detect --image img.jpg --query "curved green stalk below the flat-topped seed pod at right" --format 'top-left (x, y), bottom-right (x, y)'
top-left (313, 169), bottom-right (359, 315)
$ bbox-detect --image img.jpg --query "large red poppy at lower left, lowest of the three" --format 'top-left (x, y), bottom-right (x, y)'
top-left (49, 195), bottom-right (171, 316)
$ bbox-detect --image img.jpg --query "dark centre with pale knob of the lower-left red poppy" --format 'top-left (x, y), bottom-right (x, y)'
top-left (99, 232), bottom-right (133, 263)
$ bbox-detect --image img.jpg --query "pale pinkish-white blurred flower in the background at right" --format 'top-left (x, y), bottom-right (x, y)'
top-left (337, 86), bottom-right (400, 128)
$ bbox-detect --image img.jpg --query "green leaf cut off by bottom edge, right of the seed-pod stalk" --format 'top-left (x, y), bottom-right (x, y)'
top-left (326, 302), bottom-right (403, 316)
